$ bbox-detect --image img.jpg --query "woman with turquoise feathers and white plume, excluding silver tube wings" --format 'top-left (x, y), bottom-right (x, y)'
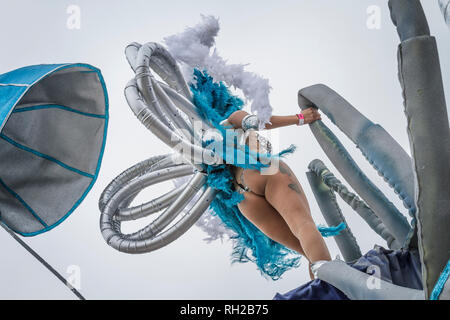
top-left (165, 16), bottom-right (331, 280)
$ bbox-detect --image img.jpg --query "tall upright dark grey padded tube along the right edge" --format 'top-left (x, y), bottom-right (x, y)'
top-left (389, 0), bottom-right (450, 298)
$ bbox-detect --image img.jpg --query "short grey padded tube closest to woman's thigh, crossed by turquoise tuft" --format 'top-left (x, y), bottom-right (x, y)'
top-left (306, 171), bottom-right (362, 262)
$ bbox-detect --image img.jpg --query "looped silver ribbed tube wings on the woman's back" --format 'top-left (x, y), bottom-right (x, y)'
top-left (99, 43), bottom-right (222, 253)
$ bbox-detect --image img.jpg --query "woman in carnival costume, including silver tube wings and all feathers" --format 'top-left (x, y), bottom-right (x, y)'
top-left (99, 17), bottom-right (334, 280)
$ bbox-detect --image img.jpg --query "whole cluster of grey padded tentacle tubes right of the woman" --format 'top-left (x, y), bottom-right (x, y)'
top-left (306, 0), bottom-right (450, 299)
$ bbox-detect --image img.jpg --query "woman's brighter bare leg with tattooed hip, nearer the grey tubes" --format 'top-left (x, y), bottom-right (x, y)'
top-left (244, 161), bottom-right (331, 262)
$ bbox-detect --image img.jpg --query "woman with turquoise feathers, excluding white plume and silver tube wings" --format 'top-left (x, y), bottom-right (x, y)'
top-left (187, 69), bottom-right (331, 279)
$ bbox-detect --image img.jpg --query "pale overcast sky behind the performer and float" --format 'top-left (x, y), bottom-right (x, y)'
top-left (0, 0), bottom-right (450, 299)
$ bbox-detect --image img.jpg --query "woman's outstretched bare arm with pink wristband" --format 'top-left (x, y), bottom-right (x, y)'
top-left (228, 107), bottom-right (322, 130)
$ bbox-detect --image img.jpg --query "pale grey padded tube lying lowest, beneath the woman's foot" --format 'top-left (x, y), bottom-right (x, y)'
top-left (317, 260), bottom-right (424, 300)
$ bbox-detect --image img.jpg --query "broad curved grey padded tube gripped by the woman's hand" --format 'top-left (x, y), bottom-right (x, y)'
top-left (299, 84), bottom-right (415, 216)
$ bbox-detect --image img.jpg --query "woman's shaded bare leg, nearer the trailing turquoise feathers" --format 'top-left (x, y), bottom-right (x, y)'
top-left (238, 192), bottom-right (305, 255)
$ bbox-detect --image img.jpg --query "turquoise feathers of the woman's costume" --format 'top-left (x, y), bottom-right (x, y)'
top-left (190, 69), bottom-right (301, 280)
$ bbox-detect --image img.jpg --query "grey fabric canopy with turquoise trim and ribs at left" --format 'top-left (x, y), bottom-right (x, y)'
top-left (0, 64), bottom-right (108, 236)
